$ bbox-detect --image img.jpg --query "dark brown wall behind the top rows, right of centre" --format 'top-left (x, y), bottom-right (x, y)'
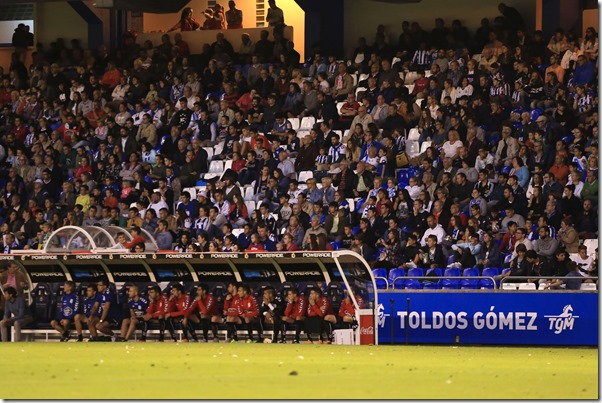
top-left (345, 0), bottom-right (535, 54)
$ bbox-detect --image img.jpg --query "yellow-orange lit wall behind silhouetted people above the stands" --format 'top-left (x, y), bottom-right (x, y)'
top-left (143, 0), bottom-right (304, 60)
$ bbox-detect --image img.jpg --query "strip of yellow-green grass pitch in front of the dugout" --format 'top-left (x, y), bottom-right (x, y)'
top-left (0, 342), bottom-right (598, 399)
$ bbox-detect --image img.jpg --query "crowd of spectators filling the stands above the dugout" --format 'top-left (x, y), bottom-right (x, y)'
top-left (0, 4), bottom-right (599, 288)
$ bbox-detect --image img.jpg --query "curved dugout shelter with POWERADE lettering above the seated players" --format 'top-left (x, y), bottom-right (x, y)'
top-left (0, 252), bottom-right (379, 344)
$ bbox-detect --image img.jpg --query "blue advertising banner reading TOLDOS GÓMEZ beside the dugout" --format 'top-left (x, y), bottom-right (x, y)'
top-left (377, 291), bottom-right (598, 346)
